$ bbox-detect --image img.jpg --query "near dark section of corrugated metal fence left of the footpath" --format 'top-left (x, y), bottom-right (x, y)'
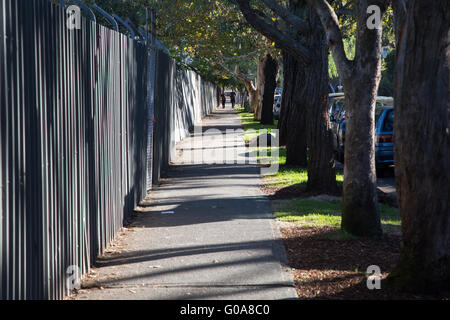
top-left (0, 0), bottom-right (216, 299)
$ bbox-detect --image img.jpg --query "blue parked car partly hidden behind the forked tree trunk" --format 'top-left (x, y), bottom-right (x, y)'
top-left (328, 93), bottom-right (394, 169)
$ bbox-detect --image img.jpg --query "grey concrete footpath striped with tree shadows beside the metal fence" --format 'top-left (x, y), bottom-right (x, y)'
top-left (71, 109), bottom-right (297, 300)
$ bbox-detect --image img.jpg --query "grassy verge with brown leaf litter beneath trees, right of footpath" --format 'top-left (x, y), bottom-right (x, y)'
top-left (238, 108), bottom-right (449, 300)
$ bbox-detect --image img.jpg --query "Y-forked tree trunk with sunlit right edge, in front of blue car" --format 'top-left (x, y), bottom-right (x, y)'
top-left (314, 0), bottom-right (387, 238)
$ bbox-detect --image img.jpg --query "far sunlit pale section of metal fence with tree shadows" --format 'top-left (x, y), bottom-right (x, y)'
top-left (153, 51), bottom-right (218, 179)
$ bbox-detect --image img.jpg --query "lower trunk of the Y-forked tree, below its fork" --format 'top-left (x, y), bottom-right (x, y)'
top-left (342, 85), bottom-right (382, 238)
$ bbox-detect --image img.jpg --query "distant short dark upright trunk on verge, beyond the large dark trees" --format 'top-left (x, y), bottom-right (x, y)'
top-left (261, 54), bottom-right (278, 125)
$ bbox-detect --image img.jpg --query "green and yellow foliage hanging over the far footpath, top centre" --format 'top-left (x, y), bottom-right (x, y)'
top-left (156, 0), bottom-right (261, 82)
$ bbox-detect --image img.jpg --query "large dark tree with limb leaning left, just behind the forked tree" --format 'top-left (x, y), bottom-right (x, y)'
top-left (234, 0), bottom-right (337, 193)
